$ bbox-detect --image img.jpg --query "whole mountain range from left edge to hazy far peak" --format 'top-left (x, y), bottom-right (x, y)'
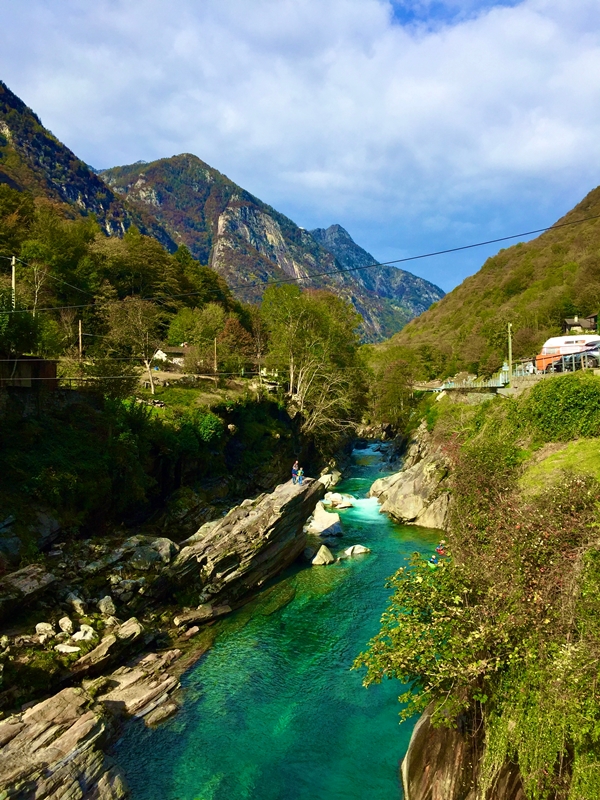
top-left (0, 82), bottom-right (442, 342)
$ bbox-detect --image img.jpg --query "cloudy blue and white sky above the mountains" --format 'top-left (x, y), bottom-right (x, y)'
top-left (0, 0), bottom-right (600, 291)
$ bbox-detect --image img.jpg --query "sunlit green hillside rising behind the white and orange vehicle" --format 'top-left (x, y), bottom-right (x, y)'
top-left (376, 187), bottom-right (600, 377)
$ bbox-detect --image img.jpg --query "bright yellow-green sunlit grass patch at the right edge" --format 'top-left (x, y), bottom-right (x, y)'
top-left (519, 439), bottom-right (600, 494)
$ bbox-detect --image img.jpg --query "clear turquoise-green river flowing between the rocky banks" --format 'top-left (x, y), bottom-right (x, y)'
top-left (115, 445), bottom-right (439, 800)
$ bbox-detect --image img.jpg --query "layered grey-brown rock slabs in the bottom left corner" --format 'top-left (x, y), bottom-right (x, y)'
top-left (0, 650), bottom-right (179, 800)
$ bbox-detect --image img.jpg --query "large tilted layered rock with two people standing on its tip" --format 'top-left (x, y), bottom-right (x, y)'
top-left (169, 478), bottom-right (325, 607)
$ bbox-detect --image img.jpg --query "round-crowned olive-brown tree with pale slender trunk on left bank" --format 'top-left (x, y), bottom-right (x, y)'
top-left (104, 297), bottom-right (162, 394)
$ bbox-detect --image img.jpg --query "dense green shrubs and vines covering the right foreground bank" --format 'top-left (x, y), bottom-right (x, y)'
top-left (357, 373), bottom-right (600, 800)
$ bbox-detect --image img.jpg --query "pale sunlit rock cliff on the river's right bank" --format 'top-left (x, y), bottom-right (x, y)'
top-left (369, 422), bottom-right (450, 530)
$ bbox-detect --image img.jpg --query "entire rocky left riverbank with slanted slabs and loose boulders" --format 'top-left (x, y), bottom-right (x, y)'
top-left (0, 477), bottom-right (330, 800)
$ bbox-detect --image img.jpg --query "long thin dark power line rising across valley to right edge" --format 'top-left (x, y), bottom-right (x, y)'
top-left (0, 209), bottom-right (600, 314)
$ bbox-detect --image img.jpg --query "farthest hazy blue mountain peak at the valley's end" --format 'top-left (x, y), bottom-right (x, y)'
top-left (311, 225), bottom-right (444, 321)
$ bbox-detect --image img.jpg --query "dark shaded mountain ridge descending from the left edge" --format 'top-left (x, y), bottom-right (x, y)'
top-left (0, 81), bottom-right (175, 249)
